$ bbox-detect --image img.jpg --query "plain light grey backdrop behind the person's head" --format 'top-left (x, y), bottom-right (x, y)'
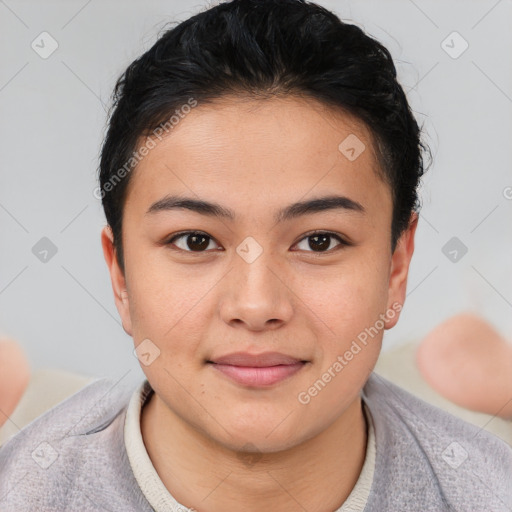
top-left (0, 0), bottom-right (512, 380)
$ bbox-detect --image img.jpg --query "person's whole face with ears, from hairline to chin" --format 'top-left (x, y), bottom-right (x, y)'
top-left (102, 97), bottom-right (416, 452)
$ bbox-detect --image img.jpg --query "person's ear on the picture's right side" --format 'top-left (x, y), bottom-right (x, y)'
top-left (385, 212), bottom-right (418, 329)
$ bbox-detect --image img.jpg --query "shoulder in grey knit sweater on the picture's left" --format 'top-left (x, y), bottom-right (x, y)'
top-left (0, 378), bottom-right (145, 510)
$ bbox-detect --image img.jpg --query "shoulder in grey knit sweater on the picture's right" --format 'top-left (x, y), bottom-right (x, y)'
top-left (363, 373), bottom-right (512, 511)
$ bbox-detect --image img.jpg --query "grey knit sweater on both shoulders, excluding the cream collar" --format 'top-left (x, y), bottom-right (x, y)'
top-left (0, 373), bottom-right (512, 512)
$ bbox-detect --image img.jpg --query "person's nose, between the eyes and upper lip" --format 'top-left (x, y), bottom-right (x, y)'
top-left (220, 251), bottom-right (293, 331)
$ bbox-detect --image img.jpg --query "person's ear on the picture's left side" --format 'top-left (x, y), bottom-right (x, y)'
top-left (101, 225), bottom-right (132, 336)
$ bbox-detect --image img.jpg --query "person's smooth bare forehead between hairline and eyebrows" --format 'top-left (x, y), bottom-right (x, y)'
top-left (125, 96), bottom-right (390, 221)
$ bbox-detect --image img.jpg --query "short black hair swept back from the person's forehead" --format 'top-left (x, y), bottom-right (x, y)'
top-left (99, 0), bottom-right (430, 272)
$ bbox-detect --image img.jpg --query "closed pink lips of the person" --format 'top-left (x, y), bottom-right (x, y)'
top-left (208, 352), bottom-right (307, 387)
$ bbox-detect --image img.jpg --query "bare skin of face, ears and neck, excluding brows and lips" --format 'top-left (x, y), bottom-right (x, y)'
top-left (101, 96), bottom-right (417, 512)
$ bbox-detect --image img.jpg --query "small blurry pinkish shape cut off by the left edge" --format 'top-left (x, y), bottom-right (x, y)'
top-left (0, 339), bottom-right (30, 427)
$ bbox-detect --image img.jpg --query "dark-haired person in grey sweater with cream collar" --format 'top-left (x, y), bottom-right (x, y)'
top-left (0, 0), bottom-right (512, 512)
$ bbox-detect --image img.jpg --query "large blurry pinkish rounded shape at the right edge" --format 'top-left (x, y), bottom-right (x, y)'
top-left (416, 313), bottom-right (512, 420)
